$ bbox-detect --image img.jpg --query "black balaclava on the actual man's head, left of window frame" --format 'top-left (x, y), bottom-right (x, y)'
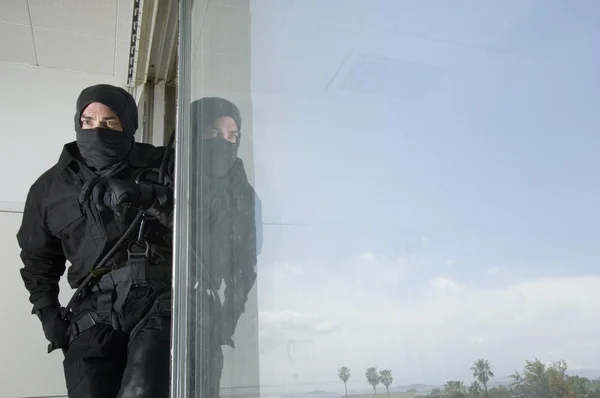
top-left (75, 84), bottom-right (138, 171)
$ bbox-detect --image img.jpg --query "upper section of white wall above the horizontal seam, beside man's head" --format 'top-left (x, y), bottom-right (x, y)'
top-left (0, 63), bottom-right (121, 208)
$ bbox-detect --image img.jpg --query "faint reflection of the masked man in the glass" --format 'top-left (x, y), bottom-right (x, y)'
top-left (190, 98), bottom-right (257, 397)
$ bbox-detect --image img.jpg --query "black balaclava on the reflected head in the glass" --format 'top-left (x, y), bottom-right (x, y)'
top-left (191, 97), bottom-right (242, 177)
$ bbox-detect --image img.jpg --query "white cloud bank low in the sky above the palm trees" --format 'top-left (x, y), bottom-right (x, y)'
top-left (259, 254), bottom-right (600, 384)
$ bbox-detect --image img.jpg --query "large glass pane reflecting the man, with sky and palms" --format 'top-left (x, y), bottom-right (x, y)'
top-left (174, 0), bottom-right (600, 397)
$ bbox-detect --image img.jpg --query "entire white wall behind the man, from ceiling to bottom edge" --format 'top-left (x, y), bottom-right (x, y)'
top-left (0, 63), bottom-right (121, 398)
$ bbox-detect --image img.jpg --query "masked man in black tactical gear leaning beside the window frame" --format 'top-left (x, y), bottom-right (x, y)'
top-left (17, 85), bottom-right (173, 398)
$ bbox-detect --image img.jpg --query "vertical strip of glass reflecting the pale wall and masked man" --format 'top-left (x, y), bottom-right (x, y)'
top-left (174, 0), bottom-right (262, 398)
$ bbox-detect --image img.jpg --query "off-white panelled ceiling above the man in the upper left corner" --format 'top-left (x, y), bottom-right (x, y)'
top-left (0, 0), bottom-right (133, 82)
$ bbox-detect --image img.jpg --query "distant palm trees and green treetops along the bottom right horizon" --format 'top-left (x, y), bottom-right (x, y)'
top-left (338, 358), bottom-right (600, 398)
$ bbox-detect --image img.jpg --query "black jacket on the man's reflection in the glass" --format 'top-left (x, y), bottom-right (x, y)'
top-left (190, 158), bottom-right (262, 337)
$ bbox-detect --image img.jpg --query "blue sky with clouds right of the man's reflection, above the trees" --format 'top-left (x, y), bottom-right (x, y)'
top-left (209, 0), bottom-right (600, 391)
